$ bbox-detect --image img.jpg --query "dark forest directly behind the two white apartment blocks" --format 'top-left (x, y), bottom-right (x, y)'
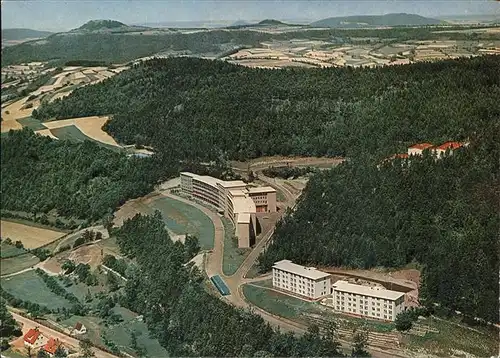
top-left (259, 123), bottom-right (500, 322)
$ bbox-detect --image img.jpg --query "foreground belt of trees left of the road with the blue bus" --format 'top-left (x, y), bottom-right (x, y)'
top-left (116, 212), bottom-right (341, 357)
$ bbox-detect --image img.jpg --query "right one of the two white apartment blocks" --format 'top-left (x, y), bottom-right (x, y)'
top-left (332, 281), bottom-right (405, 321)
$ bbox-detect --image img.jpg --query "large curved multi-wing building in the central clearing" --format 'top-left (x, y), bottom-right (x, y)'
top-left (181, 172), bottom-right (276, 247)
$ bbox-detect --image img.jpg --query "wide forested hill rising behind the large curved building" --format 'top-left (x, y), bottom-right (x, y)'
top-left (33, 56), bottom-right (500, 160)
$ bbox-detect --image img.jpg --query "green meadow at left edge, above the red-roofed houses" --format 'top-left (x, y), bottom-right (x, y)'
top-left (0, 271), bottom-right (71, 308)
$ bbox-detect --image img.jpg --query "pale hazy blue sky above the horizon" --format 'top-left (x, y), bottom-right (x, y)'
top-left (1, 0), bottom-right (500, 31)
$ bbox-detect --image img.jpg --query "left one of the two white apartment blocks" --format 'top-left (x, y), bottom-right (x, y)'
top-left (273, 260), bottom-right (331, 300)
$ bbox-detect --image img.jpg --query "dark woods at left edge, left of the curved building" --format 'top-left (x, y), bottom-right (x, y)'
top-left (0, 129), bottom-right (178, 220)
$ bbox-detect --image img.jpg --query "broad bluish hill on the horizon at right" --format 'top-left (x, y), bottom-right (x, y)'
top-left (310, 13), bottom-right (446, 28)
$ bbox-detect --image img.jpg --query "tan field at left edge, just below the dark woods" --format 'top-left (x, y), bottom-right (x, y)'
top-left (0, 220), bottom-right (64, 249)
